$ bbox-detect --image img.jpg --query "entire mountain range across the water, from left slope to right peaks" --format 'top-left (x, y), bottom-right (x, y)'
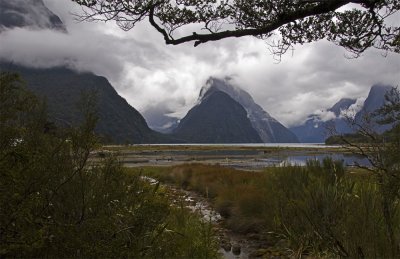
top-left (0, 0), bottom-right (390, 144)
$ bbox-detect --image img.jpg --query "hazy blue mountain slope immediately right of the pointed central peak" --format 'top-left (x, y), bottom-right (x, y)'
top-left (290, 98), bottom-right (356, 143)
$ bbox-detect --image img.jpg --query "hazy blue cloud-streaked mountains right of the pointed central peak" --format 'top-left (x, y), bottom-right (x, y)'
top-left (290, 85), bottom-right (393, 143)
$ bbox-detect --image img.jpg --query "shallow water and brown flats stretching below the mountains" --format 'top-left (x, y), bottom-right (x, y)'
top-left (119, 143), bottom-right (370, 170)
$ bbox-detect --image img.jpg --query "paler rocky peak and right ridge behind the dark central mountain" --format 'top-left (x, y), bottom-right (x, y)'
top-left (200, 78), bottom-right (299, 143)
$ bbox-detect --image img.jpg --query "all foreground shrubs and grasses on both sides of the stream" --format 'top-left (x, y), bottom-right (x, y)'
top-left (0, 73), bottom-right (400, 258)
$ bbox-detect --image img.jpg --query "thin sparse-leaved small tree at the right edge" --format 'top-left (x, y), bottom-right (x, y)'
top-left (334, 88), bottom-right (400, 256)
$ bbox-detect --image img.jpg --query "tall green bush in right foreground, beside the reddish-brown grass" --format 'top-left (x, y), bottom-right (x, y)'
top-left (272, 159), bottom-right (400, 258)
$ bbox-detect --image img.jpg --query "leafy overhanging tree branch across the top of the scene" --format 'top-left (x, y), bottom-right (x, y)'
top-left (72, 0), bottom-right (400, 55)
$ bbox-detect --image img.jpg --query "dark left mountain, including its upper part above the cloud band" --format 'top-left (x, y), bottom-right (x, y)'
top-left (0, 0), bottom-right (181, 144)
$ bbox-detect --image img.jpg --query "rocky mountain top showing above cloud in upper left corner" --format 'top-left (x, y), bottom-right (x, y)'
top-left (0, 0), bottom-right (66, 32)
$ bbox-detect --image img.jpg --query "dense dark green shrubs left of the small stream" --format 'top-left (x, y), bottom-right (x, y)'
top-left (0, 73), bottom-right (218, 258)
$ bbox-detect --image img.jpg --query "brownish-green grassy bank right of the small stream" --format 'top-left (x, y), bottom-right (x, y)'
top-left (126, 160), bottom-right (400, 257)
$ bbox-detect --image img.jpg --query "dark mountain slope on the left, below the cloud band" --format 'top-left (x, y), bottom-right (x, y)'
top-left (0, 63), bottom-right (176, 144)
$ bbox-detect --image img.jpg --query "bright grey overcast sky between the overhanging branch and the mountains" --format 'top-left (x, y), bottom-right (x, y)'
top-left (0, 0), bottom-right (400, 126)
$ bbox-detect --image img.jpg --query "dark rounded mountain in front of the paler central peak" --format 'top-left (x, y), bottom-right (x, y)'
top-left (174, 91), bottom-right (262, 143)
